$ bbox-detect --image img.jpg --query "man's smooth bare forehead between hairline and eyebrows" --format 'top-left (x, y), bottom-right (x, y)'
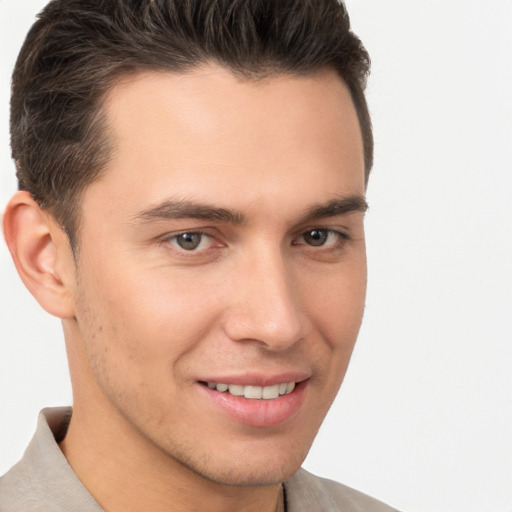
top-left (84, 65), bottom-right (364, 220)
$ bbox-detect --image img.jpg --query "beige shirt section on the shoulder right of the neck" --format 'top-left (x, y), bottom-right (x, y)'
top-left (285, 469), bottom-right (397, 512)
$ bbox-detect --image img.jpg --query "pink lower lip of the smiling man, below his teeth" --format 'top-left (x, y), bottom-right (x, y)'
top-left (199, 381), bottom-right (307, 427)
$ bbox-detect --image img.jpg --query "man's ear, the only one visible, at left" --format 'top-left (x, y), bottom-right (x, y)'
top-left (3, 191), bottom-right (75, 318)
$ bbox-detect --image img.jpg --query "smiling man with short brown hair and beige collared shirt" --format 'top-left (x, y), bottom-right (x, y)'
top-left (0, 0), bottom-right (398, 512)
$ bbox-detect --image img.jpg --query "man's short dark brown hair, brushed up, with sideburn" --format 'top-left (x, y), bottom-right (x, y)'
top-left (11, 0), bottom-right (373, 247)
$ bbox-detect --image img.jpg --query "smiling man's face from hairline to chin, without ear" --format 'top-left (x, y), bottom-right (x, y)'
top-left (65, 66), bottom-right (366, 485)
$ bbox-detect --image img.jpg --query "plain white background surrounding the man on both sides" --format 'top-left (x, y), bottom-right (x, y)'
top-left (0, 0), bottom-right (512, 512)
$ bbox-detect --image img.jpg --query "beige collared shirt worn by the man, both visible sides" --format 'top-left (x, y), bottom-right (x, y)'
top-left (0, 407), bottom-right (396, 512)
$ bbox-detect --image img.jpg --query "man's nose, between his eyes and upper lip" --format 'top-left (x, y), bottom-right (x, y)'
top-left (224, 251), bottom-right (306, 351)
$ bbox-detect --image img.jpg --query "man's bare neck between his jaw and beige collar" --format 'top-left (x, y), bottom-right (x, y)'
top-left (60, 406), bottom-right (283, 512)
